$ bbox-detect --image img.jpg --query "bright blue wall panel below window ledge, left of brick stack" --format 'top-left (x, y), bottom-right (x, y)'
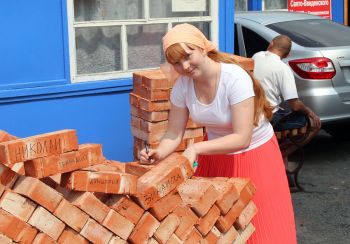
top-left (0, 91), bottom-right (133, 162)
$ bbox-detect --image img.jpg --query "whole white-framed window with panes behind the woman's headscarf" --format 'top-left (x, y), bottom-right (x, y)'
top-left (68, 0), bottom-right (218, 82)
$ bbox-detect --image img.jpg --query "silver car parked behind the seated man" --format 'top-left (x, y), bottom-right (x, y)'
top-left (234, 11), bottom-right (350, 137)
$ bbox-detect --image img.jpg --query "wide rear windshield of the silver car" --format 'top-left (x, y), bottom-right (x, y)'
top-left (267, 19), bottom-right (350, 47)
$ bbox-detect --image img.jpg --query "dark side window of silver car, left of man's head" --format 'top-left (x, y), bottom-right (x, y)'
top-left (242, 26), bottom-right (269, 58)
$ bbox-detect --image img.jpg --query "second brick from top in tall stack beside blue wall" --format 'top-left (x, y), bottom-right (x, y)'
top-left (132, 82), bottom-right (171, 102)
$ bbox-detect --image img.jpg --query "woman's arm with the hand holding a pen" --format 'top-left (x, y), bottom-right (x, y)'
top-left (140, 104), bottom-right (189, 164)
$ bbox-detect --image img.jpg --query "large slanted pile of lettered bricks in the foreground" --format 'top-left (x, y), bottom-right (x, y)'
top-left (0, 130), bottom-right (257, 244)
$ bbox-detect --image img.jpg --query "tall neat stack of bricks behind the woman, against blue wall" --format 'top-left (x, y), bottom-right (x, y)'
top-left (130, 70), bottom-right (204, 160)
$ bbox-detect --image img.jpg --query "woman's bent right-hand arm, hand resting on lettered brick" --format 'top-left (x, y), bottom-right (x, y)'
top-left (184, 97), bottom-right (254, 162)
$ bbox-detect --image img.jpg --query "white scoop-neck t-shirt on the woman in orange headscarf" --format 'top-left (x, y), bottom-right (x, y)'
top-left (170, 63), bottom-right (273, 153)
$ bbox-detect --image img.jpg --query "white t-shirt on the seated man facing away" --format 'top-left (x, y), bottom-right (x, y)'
top-left (252, 51), bottom-right (298, 112)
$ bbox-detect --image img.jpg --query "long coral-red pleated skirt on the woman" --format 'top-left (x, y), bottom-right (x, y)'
top-left (195, 136), bottom-right (297, 244)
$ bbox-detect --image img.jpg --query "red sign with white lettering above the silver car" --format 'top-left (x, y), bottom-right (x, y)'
top-left (288, 0), bottom-right (332, 19)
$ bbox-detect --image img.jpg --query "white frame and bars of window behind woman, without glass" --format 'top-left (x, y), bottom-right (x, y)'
top-left (67, 0), bottom-right (219, 83)
